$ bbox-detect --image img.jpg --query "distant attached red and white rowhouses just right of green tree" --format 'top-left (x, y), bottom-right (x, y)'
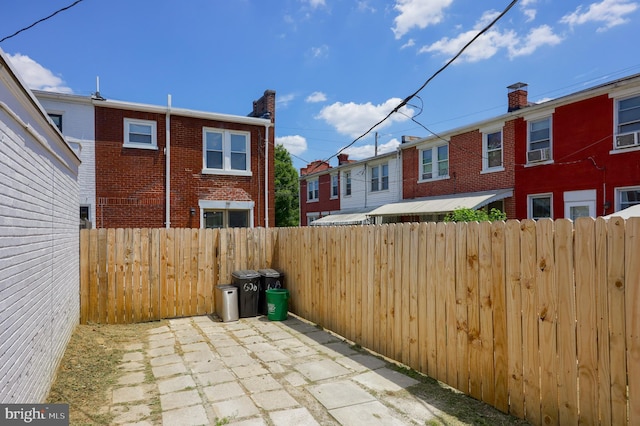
top-left (300, 151), bottom-right (401, 226)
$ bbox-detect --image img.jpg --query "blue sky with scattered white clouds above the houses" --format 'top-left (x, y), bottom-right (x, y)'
top-left (0, 0), bottom-right (640, 169)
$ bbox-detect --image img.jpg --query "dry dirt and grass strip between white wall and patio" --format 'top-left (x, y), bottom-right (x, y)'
top-left (47, 322), bottom-right (164, 425)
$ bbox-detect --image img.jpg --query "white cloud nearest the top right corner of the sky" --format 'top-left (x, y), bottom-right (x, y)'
top-left (560, 0), bottom-right (638, 31)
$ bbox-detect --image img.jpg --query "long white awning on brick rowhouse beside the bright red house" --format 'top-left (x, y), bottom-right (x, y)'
top-left (369, 189), bottom-right (513, 216)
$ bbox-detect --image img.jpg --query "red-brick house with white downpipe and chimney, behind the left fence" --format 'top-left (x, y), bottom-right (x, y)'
top-left (94, 90), bottom-right (275, 228)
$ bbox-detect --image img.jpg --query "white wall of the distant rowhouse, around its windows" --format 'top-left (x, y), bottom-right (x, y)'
top-left (340, 153), bottom-right (402, 210)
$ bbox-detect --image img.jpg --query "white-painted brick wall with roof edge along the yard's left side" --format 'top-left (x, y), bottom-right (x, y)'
top-left (0, 50), bottom-right (80, 403)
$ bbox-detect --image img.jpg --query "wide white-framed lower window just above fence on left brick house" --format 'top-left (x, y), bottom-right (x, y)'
top-left (198, 200), bottom-right (255, 228)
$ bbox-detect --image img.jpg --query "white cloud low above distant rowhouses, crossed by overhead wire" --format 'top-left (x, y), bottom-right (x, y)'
top-left (316, 98), bottom-right (413, 138)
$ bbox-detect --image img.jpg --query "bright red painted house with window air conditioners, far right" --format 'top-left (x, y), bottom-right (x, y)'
top-left (514, 74), bottom-right (640, 219)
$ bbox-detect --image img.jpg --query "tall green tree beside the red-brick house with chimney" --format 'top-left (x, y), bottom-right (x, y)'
top-left (275, 145), bottom-right (300, 226)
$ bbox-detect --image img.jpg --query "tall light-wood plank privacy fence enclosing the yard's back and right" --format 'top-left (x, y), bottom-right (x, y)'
top-left (81, 218), bottom-right (640, 425)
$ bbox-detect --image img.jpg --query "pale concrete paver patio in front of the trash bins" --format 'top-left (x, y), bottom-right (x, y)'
top-left (110, 315), bottom-right (528, 426)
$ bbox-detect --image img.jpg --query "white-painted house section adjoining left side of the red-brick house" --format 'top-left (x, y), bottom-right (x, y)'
top-left (35, 92), bottom-right (96, 228)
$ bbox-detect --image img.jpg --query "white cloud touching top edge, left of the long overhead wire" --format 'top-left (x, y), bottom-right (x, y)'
top-left (392, 0), bottom-right (453, 39)
